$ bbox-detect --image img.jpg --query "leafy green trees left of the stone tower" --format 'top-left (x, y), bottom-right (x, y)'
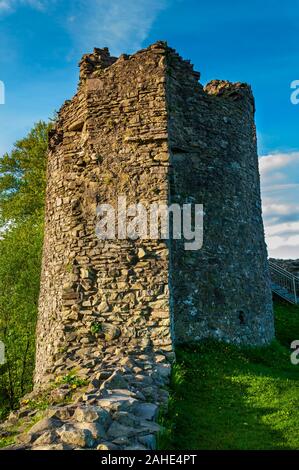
top-left (0, 122), bottom-right (50, 419)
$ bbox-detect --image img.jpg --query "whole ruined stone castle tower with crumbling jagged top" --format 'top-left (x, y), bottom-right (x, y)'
top-left (35, 42), bottom-right (274, 385)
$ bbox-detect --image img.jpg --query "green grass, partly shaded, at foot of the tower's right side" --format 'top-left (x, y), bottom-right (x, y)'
top-left (159, 301), bottom-right (299, 450)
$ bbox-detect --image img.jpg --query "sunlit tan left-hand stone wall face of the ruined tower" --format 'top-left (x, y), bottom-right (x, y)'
top-left (35, 44), bottom-right (172, 384)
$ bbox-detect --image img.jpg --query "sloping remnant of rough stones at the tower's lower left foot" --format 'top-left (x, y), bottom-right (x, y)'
top-left (0, 349), bottom-right (173, 450)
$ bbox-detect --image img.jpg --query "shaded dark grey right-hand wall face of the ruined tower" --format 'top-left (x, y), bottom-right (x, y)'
top-left (167, 51), bottom-right (274, 345)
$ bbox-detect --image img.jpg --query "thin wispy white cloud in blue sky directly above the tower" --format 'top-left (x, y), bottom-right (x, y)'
top-left (66, 0), bottom-right (167, 55)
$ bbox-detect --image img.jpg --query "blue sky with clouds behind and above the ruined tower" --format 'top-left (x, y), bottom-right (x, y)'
top-left (0, 0), bottom-right (299, 258)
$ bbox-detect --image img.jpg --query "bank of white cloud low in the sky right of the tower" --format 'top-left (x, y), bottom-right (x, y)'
top-left (260, 152), bottom-right (299, 258)
